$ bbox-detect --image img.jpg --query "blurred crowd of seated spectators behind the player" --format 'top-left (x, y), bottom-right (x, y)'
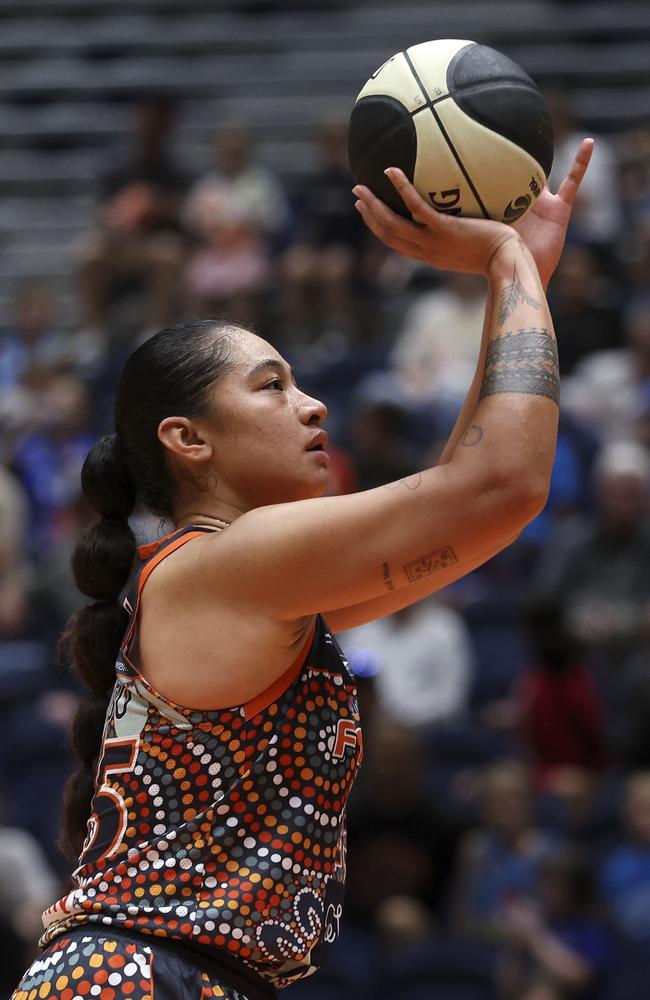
top-left (0, 95), bottom-right (650, 1000)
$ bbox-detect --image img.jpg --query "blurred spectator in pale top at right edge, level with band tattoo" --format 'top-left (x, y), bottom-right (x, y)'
top-left (560, 293), bottom-right (650, 440)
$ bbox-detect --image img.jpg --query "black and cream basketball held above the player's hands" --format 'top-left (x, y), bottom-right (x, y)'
top-left (348, 38), bottom-right (553, 223)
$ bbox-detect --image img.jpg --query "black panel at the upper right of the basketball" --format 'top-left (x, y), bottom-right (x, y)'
top-left (447, 45), bottom-right (553, 177)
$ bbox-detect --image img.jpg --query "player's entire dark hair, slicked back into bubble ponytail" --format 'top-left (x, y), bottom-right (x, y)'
top-left (61, 320), bottom-right (237, 859)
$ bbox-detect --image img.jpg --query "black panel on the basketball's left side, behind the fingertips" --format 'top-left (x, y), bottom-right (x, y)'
top-left (348, 96), bottom-right (420, 217)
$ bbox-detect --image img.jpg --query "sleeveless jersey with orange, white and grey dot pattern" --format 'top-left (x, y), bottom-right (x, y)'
top-left (41, 528), bottom-right (363, 988)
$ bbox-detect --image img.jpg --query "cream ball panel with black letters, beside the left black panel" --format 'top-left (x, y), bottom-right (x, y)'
top-left (413, 114), bottom-right (483, 218)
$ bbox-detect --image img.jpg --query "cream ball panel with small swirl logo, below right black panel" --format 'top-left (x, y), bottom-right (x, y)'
top-left (436, 98), bottom-right (545, 222)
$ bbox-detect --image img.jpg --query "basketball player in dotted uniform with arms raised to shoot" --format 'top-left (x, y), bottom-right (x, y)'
top-left (14, 141), bottom-right (591, 1000)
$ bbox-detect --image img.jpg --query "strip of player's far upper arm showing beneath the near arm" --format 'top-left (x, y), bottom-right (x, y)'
top-left (325, 535), bottom-right (519, 633)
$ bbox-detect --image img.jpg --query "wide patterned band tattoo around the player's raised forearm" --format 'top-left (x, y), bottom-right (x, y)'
top-left (481, 329), bottom-right (560, 405)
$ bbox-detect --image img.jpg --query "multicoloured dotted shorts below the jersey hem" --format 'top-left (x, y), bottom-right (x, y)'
top-left (11, 929), bottom-right (240, 1000)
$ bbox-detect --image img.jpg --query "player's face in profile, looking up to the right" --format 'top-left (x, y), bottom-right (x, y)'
top-left (202, 332), bottom-right (329, 509)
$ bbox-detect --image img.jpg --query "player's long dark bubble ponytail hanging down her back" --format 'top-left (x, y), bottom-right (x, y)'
top-left (61, 434), bottom-right (136, 859)
